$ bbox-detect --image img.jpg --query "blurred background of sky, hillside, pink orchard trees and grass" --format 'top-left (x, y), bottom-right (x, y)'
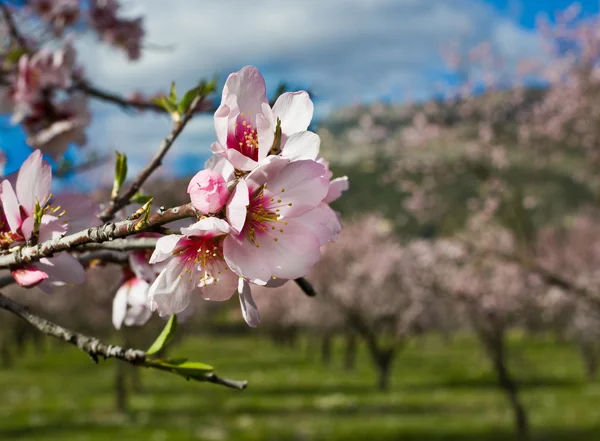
top-left (5, 0), bottom-right (600, 441)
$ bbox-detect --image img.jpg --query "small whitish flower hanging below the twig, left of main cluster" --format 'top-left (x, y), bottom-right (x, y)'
top-left (112, 269), bottom-right (152, 329)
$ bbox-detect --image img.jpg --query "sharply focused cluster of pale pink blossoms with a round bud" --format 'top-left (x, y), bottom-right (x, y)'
top-left (143, 66), bottom-right (348, 326)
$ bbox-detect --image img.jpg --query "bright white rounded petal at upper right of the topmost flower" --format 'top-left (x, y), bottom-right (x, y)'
top-left (273, 91), bottom-right (314, 135)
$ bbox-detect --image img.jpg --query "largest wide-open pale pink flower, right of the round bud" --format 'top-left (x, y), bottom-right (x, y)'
top-left (224, 156), bottom-right (331, 285)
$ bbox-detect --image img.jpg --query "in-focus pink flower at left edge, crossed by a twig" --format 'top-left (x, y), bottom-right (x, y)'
top-left (0, 150), bottom-right (90, 291)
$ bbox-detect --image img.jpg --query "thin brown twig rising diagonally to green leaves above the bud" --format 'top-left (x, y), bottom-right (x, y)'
top-left (98, 95), bottom-right (204, 222)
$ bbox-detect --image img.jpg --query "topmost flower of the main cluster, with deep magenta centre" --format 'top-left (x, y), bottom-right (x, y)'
top-left (211, 66), bottom-right (318, 171)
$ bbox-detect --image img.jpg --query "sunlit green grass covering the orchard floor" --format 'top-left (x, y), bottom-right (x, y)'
top-left (0, 330), bottom-right (600, 441)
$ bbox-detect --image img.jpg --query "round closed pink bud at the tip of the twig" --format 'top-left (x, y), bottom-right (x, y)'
top-left (188, 169), bottom-right (229, 214)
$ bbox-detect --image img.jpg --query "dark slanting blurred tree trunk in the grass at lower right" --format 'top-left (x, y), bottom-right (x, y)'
top-left (486, 332), bottom-right (529, 441)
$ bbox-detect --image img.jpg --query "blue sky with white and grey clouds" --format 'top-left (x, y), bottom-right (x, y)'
top-left (0, 0), bottom-right (599, 183)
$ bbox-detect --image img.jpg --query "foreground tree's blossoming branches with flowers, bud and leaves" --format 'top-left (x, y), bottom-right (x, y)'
top-left (0, 0), bottom-right (348, 388)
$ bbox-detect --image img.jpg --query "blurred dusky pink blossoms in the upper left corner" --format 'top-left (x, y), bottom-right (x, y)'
top-left (0, 0), bottom-right (144, 159)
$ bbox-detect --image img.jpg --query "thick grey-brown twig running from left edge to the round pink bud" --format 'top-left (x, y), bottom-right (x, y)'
top-left (0, 203), bottom-right (197, 268)
